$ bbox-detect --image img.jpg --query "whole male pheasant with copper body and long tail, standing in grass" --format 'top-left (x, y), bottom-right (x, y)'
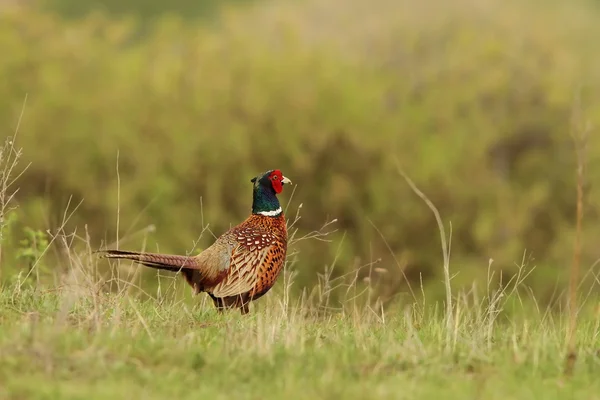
top-left (103, 169), bottom-right (292, 314)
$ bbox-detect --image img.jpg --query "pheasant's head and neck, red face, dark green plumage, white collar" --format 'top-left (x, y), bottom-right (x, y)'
top-left (251, 169), bottom-right (292, 217)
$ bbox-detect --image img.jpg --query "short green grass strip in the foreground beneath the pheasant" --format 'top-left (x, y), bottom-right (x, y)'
top-left (0, 275), bottom-right (600, 399)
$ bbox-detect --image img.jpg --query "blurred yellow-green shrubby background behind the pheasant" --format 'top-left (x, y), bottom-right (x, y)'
top-left (0, 0), bottom-right (600, 304)
